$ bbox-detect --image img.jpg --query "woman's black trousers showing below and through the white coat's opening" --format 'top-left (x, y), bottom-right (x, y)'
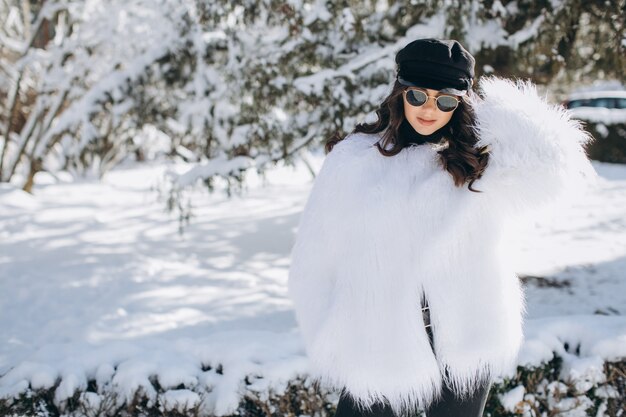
top-left (335, 300), bottom-right (491, 417)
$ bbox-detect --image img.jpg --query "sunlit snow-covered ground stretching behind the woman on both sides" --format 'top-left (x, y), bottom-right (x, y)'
top-left (0, 154), bottom-right (626, 415)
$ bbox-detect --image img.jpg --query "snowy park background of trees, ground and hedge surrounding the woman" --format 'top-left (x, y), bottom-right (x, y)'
top-left (0, 0), bottom-right (626, 417)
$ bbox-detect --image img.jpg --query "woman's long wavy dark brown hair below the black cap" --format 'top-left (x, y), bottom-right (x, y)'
top-left (324, 80), bottom-right (489, 192)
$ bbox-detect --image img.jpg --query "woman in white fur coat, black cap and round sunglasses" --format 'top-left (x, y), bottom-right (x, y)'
top-left (288, 39), bottom-right (595, 417)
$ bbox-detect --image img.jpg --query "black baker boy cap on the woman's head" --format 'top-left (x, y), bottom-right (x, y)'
top-left (396, 39), bottom-right (476, 95)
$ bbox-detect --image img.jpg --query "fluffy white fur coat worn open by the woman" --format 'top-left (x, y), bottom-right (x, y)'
top-left (288, 77), bottom-right (595, 415)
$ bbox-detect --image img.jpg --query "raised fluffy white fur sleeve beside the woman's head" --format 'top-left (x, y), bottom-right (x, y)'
top-left (473, 77), bottom-right (597, 212)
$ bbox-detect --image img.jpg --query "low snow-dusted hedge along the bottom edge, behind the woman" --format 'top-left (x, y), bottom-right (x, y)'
top-left (0, 356), bottom-right (626, 417)
